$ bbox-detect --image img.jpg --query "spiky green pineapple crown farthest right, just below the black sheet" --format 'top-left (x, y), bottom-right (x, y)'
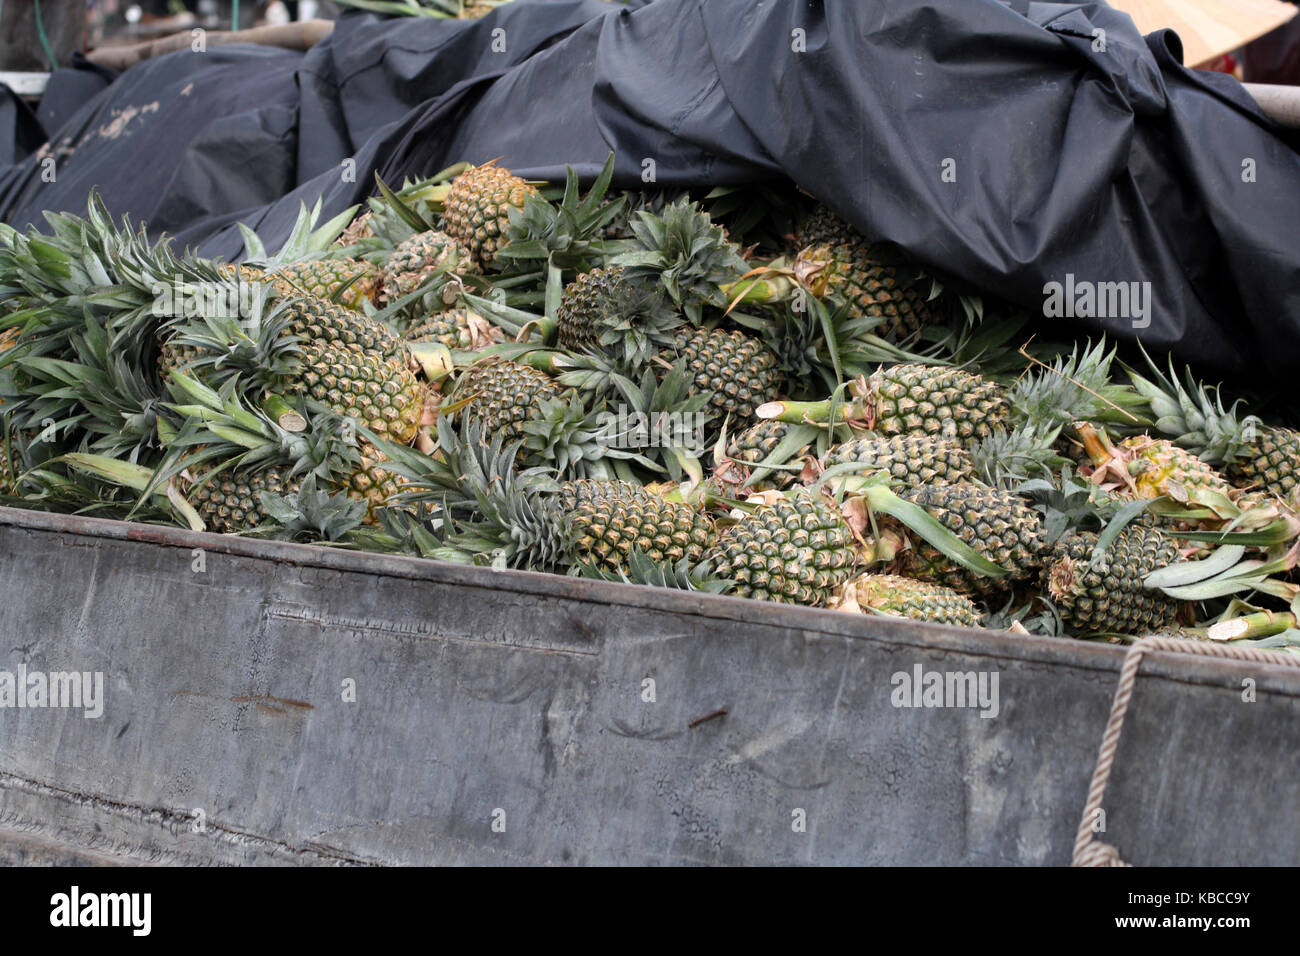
top-left (1125, 346), bottom-right (1262, 463)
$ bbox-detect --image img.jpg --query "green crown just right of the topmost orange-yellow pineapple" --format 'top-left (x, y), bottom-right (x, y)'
top-left (498, 152), bottom-right (627, 269)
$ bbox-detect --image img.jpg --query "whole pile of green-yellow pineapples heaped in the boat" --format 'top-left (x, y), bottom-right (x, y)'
top-left (0, 157), bottom-right (1300, 646)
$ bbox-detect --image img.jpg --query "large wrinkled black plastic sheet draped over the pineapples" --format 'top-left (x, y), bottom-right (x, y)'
top-left (0, 0), bottom-right (1300, 378)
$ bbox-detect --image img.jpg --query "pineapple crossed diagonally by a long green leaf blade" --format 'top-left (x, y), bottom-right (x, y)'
top-left (896, 481), bottom-right (1044, 594)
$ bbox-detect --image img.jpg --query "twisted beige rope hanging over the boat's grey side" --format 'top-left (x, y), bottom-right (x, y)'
top-left (1071, 637), bottom-right (1300, 866)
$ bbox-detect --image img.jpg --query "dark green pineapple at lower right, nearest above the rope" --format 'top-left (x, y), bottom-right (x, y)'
top-left (1043, 525), bottom-right (1179, 635)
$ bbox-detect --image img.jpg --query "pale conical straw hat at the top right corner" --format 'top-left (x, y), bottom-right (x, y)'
top-left (1110, 0), bottom-right (1297, 66)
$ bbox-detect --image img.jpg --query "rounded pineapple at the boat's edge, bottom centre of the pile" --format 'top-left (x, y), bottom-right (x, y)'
top-left (705, 493), bottom-right (857, 606)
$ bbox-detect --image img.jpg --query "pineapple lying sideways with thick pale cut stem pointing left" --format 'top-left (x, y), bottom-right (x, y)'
top-left (755, 364), bottom-right (1010, 445)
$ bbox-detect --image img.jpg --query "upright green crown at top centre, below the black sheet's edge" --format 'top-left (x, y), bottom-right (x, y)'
top-left (611, 198), bottom-right (749, 325)
